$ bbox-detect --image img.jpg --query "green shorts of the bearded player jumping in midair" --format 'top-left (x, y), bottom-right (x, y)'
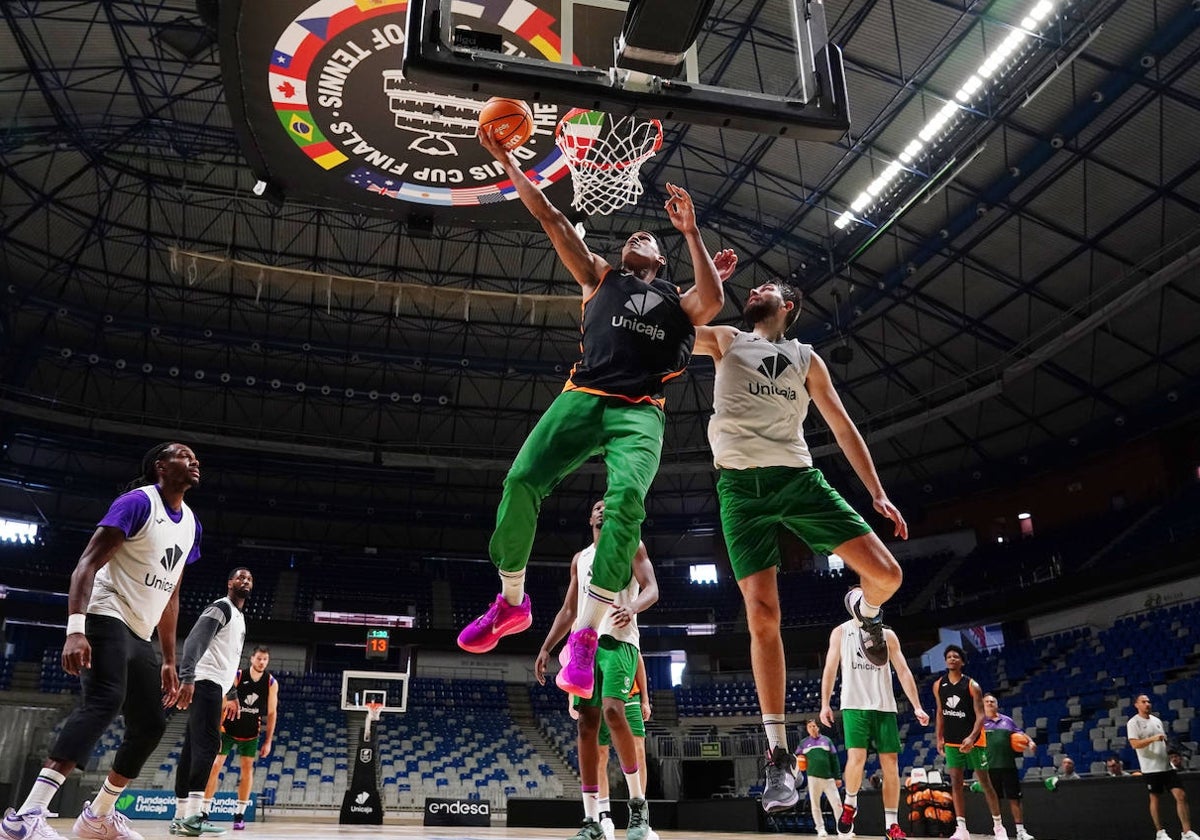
top-left (716, 467), bottom-right (871, 581)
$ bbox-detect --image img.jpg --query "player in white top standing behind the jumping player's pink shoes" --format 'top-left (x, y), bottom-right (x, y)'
top-left (534, 499), bottom-right (659, 840)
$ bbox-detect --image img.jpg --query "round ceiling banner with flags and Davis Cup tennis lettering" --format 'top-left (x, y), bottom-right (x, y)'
top-left (221, 0), bottom-right (580, 227)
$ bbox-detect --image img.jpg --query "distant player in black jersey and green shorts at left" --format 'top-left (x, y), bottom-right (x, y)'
top-left (204, 644), bottom-right (280, 830)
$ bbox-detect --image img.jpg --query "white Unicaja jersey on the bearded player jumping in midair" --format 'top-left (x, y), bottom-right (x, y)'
top-left (708, 331), bottom-right (812, 469)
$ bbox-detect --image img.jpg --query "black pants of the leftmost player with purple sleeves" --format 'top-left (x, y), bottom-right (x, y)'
top-left (50, 616), bottom-right (167, 779)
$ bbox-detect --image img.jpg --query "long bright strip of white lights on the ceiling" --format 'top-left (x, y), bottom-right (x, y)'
top-left (833, 0), bottom-right (1054, 230)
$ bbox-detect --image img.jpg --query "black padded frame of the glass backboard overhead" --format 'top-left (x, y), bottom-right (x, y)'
top-left (403, 0), bottom-right (850, 143)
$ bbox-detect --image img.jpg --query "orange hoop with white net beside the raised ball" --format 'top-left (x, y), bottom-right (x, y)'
top-left (554, 108), bottom-right (662, 216)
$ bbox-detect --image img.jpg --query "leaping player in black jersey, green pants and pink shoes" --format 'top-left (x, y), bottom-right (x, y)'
top-left (458, 131), bottom-right (737, 698)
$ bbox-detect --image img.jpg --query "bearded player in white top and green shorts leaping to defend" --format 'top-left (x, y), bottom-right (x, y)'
top-left (694, 283), bottom-right (908, 811)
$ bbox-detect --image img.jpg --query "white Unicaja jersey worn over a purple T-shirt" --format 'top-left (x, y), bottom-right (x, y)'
top-left (88, 485), bottom-right (196, 640)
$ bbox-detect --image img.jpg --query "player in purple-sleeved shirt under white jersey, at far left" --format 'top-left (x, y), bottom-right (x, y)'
top-left (0, 443), bottom-right (200, 840)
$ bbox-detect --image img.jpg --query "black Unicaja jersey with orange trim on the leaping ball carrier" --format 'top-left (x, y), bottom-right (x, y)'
top-left (563, 269), bottom-right (696, 408)
